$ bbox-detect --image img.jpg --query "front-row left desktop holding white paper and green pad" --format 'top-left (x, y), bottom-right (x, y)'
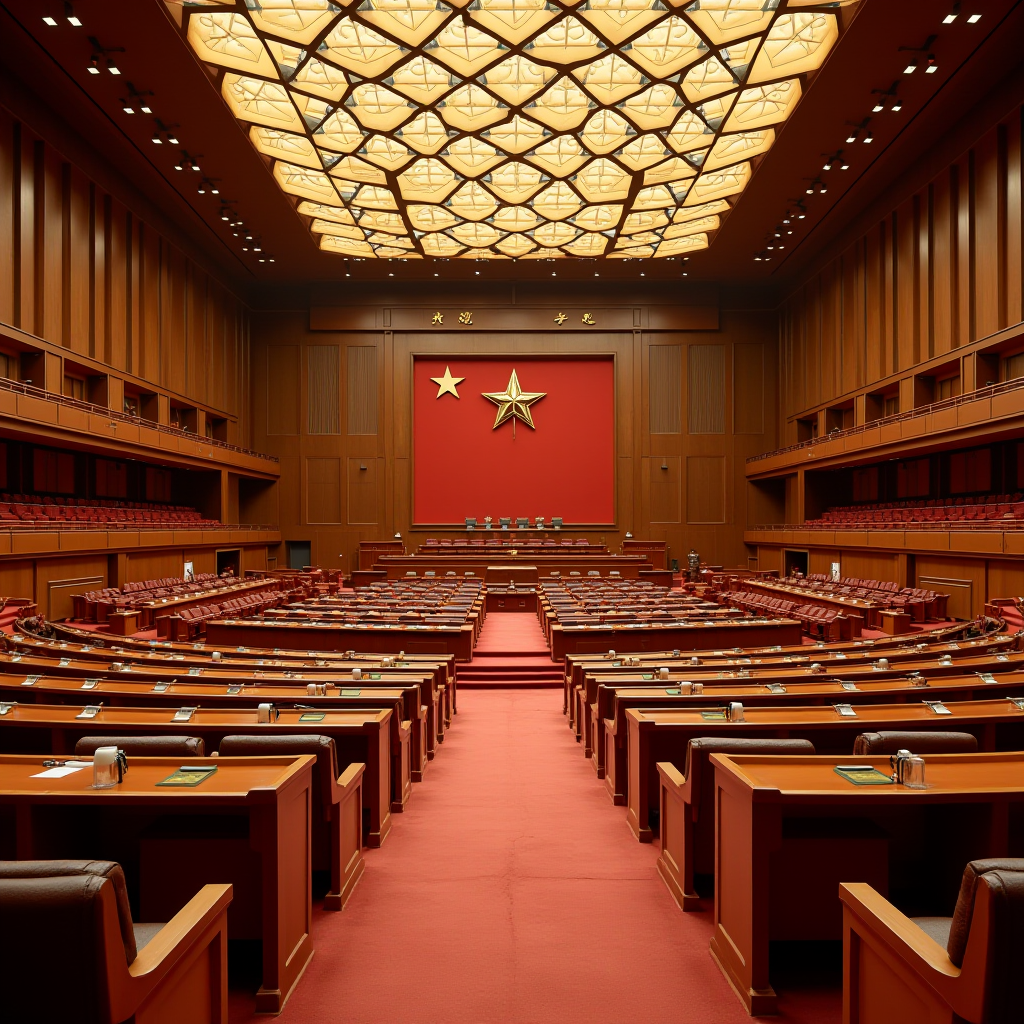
top-left (0, 754), bottom-right (316, 804)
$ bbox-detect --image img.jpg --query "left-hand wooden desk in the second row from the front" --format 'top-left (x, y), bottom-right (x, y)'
top-left (0, 703), bottom-right (391, 847)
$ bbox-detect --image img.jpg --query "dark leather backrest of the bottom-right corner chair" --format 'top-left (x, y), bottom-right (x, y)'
top-left (946, 858), bottom-right (1024, 1024)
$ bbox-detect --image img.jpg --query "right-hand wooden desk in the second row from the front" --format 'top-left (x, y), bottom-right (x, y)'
top-left (626, 699), bottom-right (1024, 843)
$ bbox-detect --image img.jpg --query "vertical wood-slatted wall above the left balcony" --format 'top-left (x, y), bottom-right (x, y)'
top-left (0, 108), bottom-right (249, 432)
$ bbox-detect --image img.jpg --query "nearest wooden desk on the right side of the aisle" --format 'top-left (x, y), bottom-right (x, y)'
top-left (711, 753), bottom-right (1024, 1015)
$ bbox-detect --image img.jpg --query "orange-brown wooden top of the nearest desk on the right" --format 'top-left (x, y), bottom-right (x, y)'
top-left (711, 749), bottom-right (1024, 803)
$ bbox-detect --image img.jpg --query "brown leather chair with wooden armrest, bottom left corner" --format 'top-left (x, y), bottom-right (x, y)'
top-left (0, 860), bottom-right (231, 1024)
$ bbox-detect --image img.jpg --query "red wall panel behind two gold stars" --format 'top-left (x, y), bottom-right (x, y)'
top-left (413, 356), bottom-right (615, 526)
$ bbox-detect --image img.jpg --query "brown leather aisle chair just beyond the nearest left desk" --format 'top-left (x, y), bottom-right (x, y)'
top-left (217, 733), bottom-right (366, 910)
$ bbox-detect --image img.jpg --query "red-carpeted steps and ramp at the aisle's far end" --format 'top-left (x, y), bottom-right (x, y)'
top-left (459, 611), bottom-right (562, 689)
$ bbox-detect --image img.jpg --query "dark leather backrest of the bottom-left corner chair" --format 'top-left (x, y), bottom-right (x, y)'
top-left (0, 860), bottom-right (137, 1024)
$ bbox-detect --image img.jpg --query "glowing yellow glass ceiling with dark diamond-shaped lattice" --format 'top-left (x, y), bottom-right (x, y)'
top-left (175, 0), bottom-right (856, 259)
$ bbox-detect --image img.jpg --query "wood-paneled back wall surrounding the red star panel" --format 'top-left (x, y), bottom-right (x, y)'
top-left (252, 301), bottom-right (778, 567)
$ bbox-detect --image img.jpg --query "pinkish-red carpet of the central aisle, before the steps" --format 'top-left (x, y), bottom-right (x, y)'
top-left (232, 689), bottom-right (841, 1024)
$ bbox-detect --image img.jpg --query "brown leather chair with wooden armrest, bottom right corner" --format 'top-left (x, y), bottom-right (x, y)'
top-left (840, 858), bottom-right (1024, 1024)
